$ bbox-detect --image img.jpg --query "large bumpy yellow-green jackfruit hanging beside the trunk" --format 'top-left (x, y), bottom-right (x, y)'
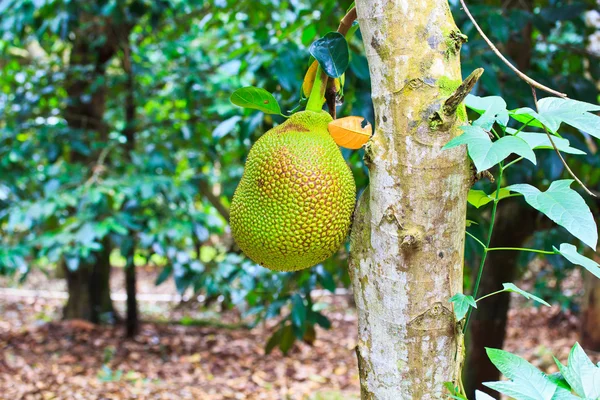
top-left (230, 111), bottom-right (356, 271)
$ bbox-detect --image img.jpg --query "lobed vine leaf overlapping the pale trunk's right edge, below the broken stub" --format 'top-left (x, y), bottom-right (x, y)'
top-left (444, 125), bottom-right (536, 172)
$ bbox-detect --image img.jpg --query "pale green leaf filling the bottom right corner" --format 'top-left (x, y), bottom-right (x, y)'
top-left (554, 343), bottom-right (600, 399)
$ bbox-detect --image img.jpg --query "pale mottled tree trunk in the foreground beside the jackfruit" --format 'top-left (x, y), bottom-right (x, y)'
top-left (350, 0), bottom-right (470, 400)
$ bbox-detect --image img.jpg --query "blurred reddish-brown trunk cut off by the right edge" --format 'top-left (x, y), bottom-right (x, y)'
top-left (581, 271), bottom-right (600, 351)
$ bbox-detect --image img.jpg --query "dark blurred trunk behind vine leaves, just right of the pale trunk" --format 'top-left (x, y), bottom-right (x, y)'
top-left (464, 199), bottom-right (538, 399)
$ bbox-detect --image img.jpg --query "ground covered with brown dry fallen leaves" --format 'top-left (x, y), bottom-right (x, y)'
top-left (0, 269), bottom-right (597, 400)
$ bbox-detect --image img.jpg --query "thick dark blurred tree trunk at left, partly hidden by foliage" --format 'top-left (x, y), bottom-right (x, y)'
top-left (63, 20), bottom-right (124, 323)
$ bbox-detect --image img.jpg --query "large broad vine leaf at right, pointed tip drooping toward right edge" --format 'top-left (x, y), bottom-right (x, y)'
top-left (507, 179), bottom-right (598, 250)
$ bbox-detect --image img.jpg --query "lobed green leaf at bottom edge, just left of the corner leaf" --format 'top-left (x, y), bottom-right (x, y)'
top-left (483, 348), bottom-right (558, 400)
